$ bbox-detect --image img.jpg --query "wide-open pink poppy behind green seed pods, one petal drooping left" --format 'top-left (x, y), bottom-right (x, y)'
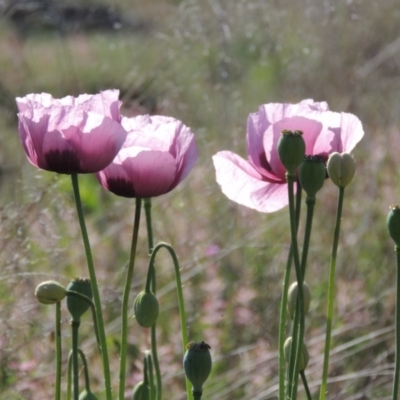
top-left (213, 99), bottom-right (364, 213)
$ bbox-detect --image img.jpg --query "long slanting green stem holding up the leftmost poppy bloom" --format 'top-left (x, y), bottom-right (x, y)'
top-left (71, 174), bottom-right (112, 400)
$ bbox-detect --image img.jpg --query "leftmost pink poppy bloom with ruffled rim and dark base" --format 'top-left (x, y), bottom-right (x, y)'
top-left (16, 90), bottom-right (127, 174)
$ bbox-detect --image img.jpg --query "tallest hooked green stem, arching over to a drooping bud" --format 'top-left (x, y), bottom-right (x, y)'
top-left (146, 242), bottom-right (193, 400)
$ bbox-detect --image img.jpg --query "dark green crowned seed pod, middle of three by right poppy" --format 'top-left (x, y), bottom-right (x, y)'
top-left (299, 156), bottom-right (326, 199)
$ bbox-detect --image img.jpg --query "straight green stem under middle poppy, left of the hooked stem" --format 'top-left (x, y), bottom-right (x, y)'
top-left (119, 198), bottom-right (142, 400)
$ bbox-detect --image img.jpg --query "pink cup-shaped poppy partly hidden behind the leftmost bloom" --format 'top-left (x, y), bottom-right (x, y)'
top-left (97, 115), bottom-right (198, 198)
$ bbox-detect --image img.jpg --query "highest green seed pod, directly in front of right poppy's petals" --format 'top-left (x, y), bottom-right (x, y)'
top-left (278, 130), bottom-right (306, 174)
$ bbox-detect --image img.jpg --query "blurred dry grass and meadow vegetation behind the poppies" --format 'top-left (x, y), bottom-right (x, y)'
top-left (0, 0), bottom-right (400, 400)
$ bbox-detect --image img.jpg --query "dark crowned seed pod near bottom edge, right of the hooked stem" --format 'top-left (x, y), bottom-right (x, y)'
top-left (183, 342), bottom-right (212, 393)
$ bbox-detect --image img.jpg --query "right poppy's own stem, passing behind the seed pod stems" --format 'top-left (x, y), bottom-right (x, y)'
top-left (278, 182), bottom-right (302, 400)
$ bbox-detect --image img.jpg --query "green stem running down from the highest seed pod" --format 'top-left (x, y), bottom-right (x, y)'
top-left (286, 173), bottom-right (304, 400)
